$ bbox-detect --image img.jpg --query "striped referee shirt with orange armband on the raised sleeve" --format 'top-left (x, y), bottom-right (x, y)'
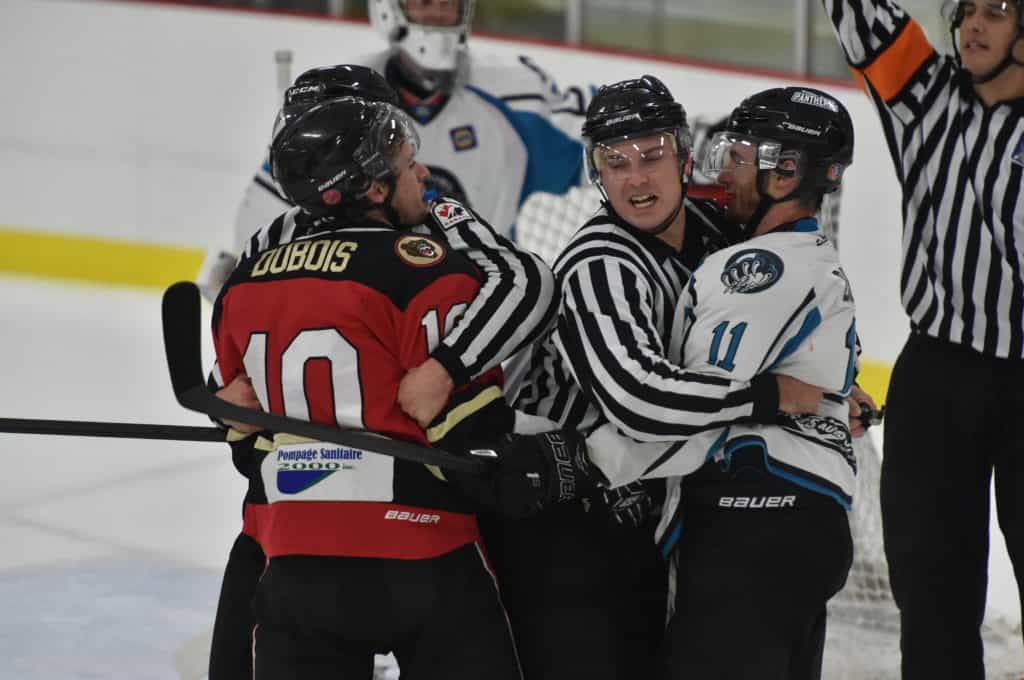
top-left (823, 0), bottom-right (1024, 358)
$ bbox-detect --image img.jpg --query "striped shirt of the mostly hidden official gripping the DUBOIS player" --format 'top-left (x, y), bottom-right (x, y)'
top-left (231, 199), bottom-right (558, 385)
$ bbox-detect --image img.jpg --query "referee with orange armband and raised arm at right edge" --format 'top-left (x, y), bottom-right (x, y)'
top-left (823, 0), bottom-right (1024, 680)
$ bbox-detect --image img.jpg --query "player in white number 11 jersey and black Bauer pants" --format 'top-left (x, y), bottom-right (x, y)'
top-left (577, 88), bottom-right (857, 680)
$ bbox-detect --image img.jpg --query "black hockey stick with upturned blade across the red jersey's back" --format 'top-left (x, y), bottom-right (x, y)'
top-left (163, 281), bottom-right (489, 474)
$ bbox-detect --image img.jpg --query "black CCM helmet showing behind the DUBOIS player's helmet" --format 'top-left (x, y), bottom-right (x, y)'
top-left (270, 63), bottom-right (398, 140)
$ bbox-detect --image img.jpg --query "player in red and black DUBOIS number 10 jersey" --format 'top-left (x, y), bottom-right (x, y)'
top-left (211, 97), bottom-right (582, 680)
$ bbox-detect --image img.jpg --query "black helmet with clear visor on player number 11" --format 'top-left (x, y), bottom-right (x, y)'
top-left (701, 87), bottom-right (853, 232)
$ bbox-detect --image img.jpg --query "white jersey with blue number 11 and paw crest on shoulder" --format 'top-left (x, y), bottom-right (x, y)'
top-left (588, 219), bottom-right (858, 530)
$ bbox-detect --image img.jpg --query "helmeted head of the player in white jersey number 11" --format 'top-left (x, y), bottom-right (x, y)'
top-left (701, 87), bottom-right (853, 238)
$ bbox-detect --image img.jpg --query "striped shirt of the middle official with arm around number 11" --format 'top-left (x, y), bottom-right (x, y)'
top-left (516, 200), bottom-right (778, 440)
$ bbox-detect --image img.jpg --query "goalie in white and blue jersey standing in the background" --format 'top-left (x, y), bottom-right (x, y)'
top-left (197, 0), bottom-right (586, 300)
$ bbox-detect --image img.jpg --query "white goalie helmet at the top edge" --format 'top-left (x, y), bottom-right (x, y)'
top-left (368, 0), bottom-right (476, 74)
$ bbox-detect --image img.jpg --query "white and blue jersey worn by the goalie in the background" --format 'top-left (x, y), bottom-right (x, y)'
top-left (225, 50), bottom-right (586, 253)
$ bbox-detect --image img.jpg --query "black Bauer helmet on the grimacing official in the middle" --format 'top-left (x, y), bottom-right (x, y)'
top-left (583, 76), bottom-right (691, 233)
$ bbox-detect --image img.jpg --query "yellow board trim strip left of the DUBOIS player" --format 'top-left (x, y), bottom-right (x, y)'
top-left (0, 226), bottom-right (204, 289)
